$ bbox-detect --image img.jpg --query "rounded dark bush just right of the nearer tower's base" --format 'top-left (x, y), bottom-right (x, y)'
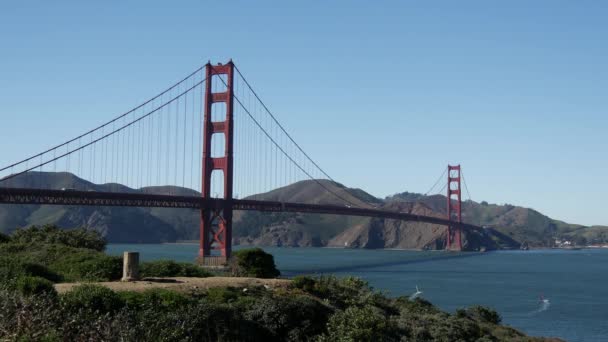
top-left (231, 248), bottom-right (281, 278)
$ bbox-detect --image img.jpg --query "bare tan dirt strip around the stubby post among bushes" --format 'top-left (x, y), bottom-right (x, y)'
top-left (55, 277), bottom-right (291, 293)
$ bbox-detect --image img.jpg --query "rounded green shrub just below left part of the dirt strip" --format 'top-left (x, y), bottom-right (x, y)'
top-left (61, 284), bottom-right (125, 312)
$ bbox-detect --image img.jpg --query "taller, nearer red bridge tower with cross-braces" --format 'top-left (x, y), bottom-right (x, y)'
top-left (199, 60), bottom-right (234, 266)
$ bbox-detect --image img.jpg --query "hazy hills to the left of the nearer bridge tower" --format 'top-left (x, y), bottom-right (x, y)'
top-left (0, 172), bottom-right (198, 243)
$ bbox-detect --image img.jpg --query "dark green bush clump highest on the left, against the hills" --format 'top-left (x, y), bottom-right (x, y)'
top-left (11, 225), bottom-right (106, 252)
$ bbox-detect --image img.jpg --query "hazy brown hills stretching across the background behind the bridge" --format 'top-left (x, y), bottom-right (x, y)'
top-left (0, 172), bottom-right (608, 249)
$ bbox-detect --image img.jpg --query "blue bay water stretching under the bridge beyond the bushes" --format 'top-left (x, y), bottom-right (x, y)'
top-left (107, 244), bottom-right (608, 341)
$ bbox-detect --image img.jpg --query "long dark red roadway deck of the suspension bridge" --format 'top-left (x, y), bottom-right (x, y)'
top-left (0, 188), bottom-right (483, 231)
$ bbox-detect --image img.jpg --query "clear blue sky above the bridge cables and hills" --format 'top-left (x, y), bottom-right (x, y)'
top-left (0, 0), bottom-right (608, 224)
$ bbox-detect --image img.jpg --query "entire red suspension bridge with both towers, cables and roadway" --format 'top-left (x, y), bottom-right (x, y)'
top-left (0, 61), bottom-right (476, 265)
